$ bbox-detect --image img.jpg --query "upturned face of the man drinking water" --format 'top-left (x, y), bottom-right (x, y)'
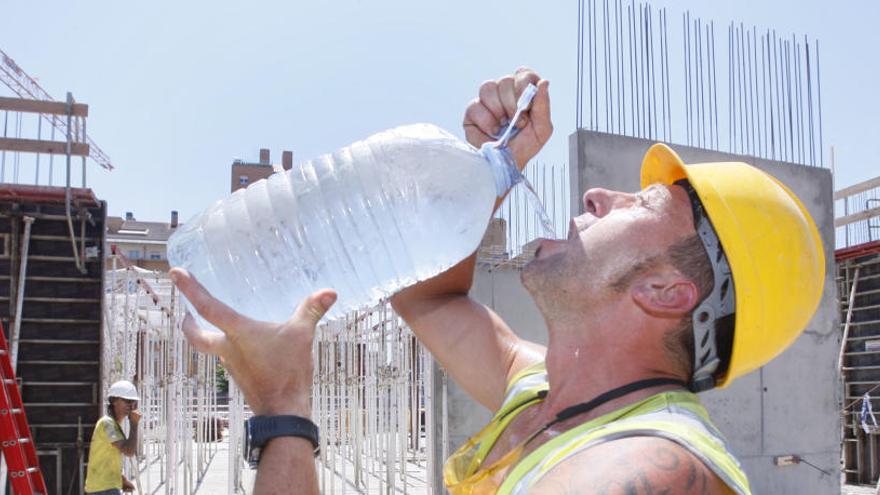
top-left (522, 184), bottom-right (694, 316)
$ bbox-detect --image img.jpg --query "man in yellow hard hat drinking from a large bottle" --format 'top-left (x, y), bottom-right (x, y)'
top-left (171, 69), bottom-right (824, 495)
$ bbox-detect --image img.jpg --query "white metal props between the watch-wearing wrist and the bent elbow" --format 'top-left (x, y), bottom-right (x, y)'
top-left (312, 302), bottom-right (446, 493)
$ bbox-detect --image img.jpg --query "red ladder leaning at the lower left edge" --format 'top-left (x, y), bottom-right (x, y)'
top-left (0, 324), bottom-right (46, 495)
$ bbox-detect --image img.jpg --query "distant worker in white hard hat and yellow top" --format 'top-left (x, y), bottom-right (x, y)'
top-left (85, 380), bottom-right (141, 495)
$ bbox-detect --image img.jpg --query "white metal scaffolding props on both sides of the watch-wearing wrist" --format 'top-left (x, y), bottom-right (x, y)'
top-left (102, 254), bottom-right (446, 494)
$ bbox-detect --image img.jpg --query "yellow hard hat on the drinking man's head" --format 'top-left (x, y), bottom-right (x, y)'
top-left (641, 144), bottom-right (825, 389)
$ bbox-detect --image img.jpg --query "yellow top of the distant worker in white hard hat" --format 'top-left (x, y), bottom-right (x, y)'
top-left (85, 416), bottom-right (125, 493)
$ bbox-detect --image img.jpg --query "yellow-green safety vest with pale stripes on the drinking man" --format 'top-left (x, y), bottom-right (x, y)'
top-left (444, 363), bottom-right (751, 495)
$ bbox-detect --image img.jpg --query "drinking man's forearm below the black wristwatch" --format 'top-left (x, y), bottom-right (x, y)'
top-left (254, 437), bottom-right (319, 495)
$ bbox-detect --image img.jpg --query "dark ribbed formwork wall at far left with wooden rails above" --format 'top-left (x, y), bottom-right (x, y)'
top-left (0, 45), bottom-right (113, 493)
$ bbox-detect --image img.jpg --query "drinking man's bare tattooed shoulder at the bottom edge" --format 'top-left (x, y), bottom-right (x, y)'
top-left (530, 437), bottom-right (731, 495)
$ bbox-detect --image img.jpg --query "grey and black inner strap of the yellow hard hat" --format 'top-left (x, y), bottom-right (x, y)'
top-left (675, 179), bottom-right (736, 392)
